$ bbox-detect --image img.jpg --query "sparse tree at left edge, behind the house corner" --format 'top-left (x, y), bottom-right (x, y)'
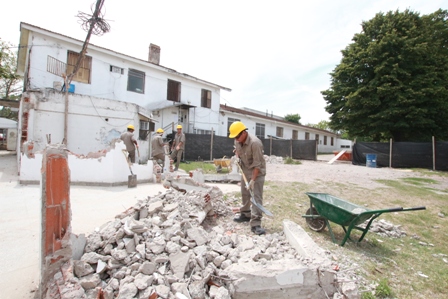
top-left (0, 39), bottom-right (22, 100)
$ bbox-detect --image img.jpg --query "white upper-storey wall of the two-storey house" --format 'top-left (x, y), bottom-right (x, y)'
top-left (22, 30), bottom-right (221, 136)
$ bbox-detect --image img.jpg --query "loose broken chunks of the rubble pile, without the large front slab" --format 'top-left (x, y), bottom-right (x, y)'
top-left (46, 187), bottom-right (334, 299)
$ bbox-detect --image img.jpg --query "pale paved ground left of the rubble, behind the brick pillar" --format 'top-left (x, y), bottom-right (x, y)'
top-left (0, 151), bottom-right (240, 299)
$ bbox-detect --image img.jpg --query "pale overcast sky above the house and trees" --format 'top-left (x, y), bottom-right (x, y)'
top-left (0, 0), bottom-right (448, 124)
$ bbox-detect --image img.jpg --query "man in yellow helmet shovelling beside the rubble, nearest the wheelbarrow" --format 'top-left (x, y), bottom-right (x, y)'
top-left (229, 121), bottom-right (266, 235)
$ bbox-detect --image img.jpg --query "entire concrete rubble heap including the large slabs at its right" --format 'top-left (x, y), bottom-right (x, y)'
top-left (41, 178), bottom-right (359, 299)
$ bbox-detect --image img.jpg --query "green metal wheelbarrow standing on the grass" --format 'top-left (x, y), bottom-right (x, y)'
top-left (302, 192), bottom-right (426, 246)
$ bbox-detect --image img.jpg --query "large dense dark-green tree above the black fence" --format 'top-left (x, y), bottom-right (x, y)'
top-left (322, 10), bottom-right (448, 141)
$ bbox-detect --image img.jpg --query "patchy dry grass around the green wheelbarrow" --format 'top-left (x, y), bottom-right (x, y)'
top-left (247, 170), bottom-right (448, 299)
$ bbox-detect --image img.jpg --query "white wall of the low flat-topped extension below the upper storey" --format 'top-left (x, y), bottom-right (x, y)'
top-left (19, 90), bottom-right (149, 161)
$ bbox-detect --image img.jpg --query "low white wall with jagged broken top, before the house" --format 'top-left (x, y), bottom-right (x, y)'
top-left (19, 142), bottom-right (153, 186)
